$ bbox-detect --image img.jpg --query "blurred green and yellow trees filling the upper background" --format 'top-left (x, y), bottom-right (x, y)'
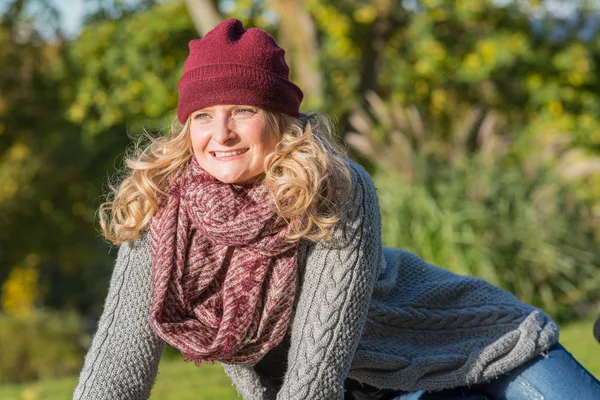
top-left (0, 0), bottom-right (600, 320)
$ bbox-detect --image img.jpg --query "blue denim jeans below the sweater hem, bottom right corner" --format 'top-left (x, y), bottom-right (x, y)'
top-left (393, 344), bottom-right (600, 400)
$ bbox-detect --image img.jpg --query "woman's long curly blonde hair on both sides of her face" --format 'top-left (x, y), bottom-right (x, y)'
top-left (99, 110), bottom-right (351, 245)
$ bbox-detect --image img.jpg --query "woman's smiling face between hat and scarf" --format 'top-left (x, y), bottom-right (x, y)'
top-left (190, 105), bottom-right (277, 183)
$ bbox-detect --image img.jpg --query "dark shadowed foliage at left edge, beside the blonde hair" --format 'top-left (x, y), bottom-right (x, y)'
top-left (0, 16), bottom-right (122, 311)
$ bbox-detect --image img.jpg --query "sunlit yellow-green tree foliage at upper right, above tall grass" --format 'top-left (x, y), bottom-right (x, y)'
top-left (306, 0), bottom-right (600, 198)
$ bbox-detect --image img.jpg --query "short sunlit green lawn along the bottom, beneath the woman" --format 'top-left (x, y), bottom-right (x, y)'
top-left (0, 321), bottom-right (600, 400)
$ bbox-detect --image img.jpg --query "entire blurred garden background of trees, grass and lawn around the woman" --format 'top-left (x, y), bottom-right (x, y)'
top-left (0, 0), bottom-right (600, 400)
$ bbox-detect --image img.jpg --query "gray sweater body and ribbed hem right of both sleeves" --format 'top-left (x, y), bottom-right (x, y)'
top-left (348, 248), bottom-right (558, 391)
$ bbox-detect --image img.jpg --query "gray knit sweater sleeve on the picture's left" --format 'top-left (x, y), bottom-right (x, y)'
top-left (73, 233), bottom-right (164, 400)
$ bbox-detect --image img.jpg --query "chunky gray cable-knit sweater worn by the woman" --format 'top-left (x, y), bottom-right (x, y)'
top-left (74, 163), bottom-right (558, 400)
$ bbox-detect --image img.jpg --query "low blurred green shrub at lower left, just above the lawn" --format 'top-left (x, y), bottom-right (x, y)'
top-left (0, 312), bottom-right (85, 383)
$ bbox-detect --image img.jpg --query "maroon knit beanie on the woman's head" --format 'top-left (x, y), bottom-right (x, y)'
top-left (177, 18), bottom-right (303, 124)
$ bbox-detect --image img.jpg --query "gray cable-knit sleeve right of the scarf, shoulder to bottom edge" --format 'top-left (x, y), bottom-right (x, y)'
top-left (277, 163), bottom-right (382, 400)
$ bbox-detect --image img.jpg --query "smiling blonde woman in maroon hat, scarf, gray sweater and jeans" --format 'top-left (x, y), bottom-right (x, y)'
top-left (75, 19), bottom-right (600, 400)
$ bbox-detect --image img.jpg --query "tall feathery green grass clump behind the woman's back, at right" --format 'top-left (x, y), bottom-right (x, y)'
top-left (347, 95), bottom-right (600, 320)
